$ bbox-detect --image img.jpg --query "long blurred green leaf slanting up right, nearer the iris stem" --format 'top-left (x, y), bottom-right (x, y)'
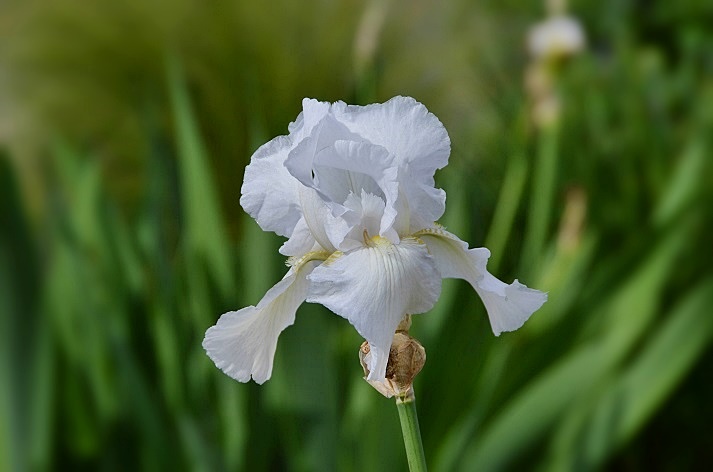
top-left (456, 226), bottom-right (686, 470)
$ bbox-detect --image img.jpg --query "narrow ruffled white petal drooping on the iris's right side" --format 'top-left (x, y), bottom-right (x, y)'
top-left (418, 228), bottom-right (547, 336)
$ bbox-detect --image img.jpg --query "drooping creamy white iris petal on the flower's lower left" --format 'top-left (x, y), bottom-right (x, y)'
top-left (203, 262), bottom-right (316, 384)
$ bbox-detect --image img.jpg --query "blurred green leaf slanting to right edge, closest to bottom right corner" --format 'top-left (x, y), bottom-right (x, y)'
top-left (548, 277), bottom-right (713, 470)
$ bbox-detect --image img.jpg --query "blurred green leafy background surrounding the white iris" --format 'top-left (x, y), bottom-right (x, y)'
top-left (0, 0), bottom-right (713, 471)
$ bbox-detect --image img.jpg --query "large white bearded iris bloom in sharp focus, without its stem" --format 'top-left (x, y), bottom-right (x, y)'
top-left (203, 97), bottom-right (547, 383)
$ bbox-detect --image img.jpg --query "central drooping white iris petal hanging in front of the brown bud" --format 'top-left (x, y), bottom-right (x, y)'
top-left (307, 236), bottom-right (441, 380)
